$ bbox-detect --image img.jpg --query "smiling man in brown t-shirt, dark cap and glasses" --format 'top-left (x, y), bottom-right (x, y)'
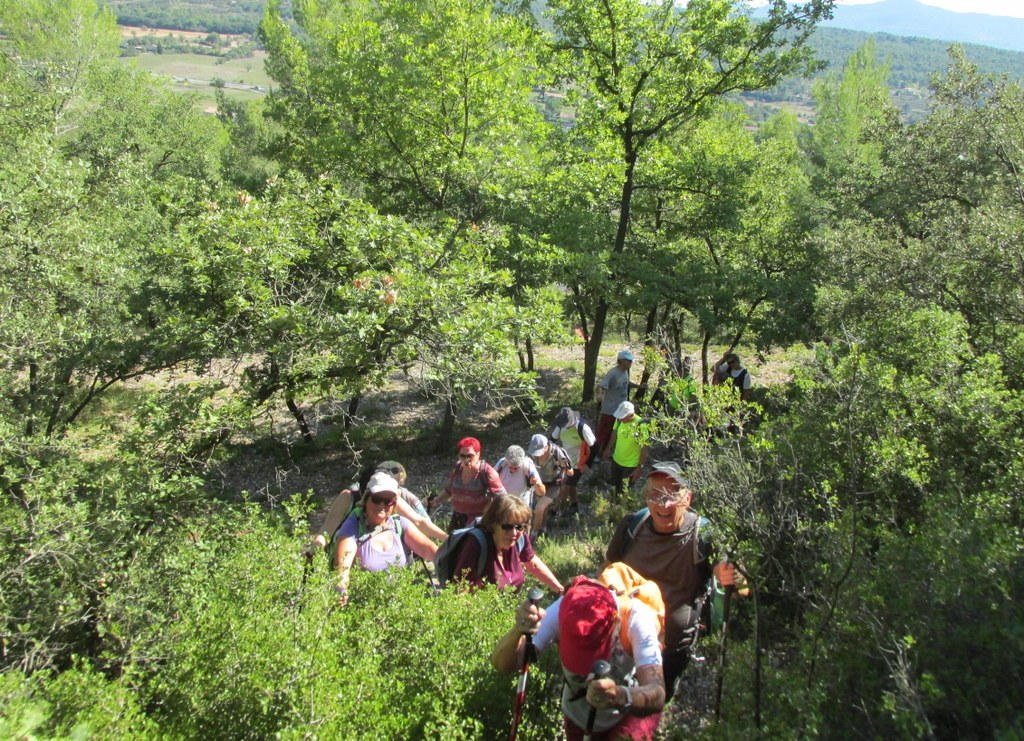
top-left (605, 463), bottom-right (735, 698)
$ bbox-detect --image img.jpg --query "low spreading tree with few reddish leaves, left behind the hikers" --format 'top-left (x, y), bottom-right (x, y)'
top-left (175, 177), bottom-right (525, 440)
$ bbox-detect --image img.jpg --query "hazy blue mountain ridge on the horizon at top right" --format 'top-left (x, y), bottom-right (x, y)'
top-left (822, 0), bottom-right (1024, 51)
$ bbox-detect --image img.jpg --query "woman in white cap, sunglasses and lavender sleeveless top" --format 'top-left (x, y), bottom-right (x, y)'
top-left (335, 472), bottom-right (437, 604)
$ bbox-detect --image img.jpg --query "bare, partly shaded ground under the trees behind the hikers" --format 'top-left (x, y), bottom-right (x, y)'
top-left (209, 343), bottom-right (806, 515)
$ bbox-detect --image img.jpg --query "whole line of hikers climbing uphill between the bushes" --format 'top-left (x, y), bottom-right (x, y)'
top-left (306, 350), bottom-right (750, 741)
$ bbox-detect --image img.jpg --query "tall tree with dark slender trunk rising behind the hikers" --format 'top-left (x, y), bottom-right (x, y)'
top-left (550, 0), bottom-right (831, 401)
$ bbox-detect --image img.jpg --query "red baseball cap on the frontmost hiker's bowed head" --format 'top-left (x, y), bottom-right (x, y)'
top-left (558, 576), bottom-right (618, 677)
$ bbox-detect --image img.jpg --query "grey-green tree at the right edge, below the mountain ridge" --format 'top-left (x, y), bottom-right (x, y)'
top-left (822, 47), bottom-right (1024, 378)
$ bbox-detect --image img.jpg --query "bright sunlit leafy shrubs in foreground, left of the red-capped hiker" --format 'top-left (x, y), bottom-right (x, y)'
top-left (117, 511), bottom-right (558, 738)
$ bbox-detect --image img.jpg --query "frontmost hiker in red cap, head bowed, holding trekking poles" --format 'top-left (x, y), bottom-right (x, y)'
top-left (490, 576), bottom-right (665, 741)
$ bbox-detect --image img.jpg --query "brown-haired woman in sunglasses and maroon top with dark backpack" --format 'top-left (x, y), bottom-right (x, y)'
top-left (454, 495), bottom-right (562, 595)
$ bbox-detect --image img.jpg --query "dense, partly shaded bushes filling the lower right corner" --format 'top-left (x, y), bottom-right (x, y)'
top-left (693, 337), bottom-right (1024, 738)
